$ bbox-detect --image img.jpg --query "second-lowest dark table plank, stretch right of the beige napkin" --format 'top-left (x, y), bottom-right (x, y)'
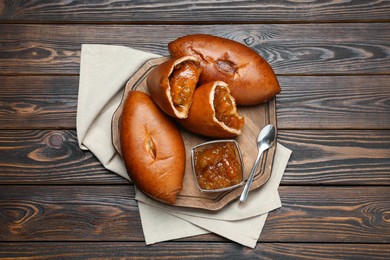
top-left (260, 186), bottom-right (390, 243)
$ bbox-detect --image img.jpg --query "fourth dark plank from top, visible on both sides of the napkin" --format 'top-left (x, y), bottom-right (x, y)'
top-left (0, 130), bottom-right (390, 185)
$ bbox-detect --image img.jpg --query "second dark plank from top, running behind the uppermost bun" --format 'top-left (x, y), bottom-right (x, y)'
top-left (0, 23), bottom-right (390, 75)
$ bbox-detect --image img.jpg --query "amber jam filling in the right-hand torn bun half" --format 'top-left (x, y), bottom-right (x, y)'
top-left (214, 86), bottom-right (244, 129)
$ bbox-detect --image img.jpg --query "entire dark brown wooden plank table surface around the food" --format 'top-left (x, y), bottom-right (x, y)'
top-left (0, 0), bottom-right (390, 259)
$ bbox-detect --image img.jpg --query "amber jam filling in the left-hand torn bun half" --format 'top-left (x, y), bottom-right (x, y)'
top-left (169, 61), bottom-right (201, 112)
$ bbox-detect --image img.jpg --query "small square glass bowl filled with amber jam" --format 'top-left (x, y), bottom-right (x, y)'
top-left (191, 140), bottom-right (244, 192)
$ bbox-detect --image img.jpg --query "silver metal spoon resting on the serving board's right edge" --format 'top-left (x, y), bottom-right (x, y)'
top-left (240, 125), bottom-right (276, 203)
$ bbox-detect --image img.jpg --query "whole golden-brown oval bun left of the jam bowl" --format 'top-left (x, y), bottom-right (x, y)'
top-left (120, 91), bottom-right (186, 204)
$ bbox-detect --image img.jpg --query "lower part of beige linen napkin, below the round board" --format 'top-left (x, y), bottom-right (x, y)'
top-left (136, 144), bottom-right (291, 248)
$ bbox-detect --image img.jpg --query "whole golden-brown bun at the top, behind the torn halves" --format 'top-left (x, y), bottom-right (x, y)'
top-left (168, 34), bottom-right (281, 105)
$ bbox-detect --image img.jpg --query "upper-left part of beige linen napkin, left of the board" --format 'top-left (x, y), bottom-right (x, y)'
top-left (76, 44), bottom-right (159, 180)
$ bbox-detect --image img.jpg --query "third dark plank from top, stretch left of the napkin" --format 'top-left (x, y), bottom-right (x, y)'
top-left (0, 76), bottom-right (78, 129)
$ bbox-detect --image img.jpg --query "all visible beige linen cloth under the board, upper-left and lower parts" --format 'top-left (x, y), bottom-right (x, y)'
top-left (77, 44), bottom-right (291, 248)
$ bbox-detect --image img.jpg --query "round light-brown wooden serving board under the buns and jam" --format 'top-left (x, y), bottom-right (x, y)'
top-left (112, 57), bottom-right (276, 211)
